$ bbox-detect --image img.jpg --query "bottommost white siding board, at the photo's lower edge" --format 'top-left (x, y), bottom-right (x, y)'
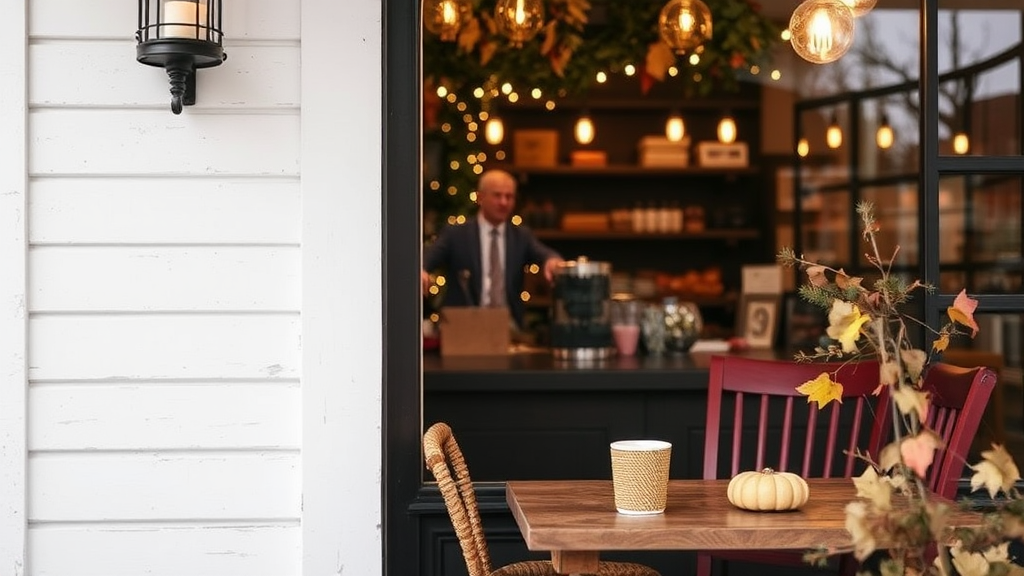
top-left (27, 524), bottom-right (302, 576)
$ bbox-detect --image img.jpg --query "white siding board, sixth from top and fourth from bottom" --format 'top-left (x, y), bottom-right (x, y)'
top-left (29, 314), bottom-right (300, 381)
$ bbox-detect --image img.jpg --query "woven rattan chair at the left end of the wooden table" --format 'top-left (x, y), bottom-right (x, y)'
top-left (423, 422), bottom-right (660, 576)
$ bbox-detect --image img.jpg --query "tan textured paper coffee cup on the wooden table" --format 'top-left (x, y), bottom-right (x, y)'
top-left (611, 440), bottom-right (672, 515)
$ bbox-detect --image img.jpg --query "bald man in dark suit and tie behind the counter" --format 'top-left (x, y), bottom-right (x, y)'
top-left (421, 170), bottom-right (562, 326)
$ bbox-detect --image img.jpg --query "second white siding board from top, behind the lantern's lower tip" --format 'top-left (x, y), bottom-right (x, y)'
top-left (29, 40), bottom-right (300, 109)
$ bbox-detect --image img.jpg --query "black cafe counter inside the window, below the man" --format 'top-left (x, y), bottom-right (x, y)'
top-left (423, 351), bottom-right (778, 482)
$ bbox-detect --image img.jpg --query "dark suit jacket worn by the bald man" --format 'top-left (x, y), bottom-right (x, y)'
top-left (423, 216), bottom-right (559, 326)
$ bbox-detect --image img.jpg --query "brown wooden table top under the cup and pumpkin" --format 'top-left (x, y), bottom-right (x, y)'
top-left (505, 479), bottom-right (977, 551)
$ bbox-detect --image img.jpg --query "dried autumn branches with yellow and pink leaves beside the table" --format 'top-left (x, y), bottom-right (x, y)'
top-left (777, 202), bottom-right (1024, 576)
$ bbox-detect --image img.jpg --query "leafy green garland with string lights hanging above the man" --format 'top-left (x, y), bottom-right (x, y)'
top-left (423, 0), bottom-right (780, 228)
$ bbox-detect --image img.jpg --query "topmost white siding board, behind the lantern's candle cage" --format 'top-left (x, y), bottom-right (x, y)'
top-left (28, 0), bottom-right (299, 40)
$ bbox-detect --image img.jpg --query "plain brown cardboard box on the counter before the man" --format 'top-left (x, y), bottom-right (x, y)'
top-left (440, 306), bottom-right (512, 356)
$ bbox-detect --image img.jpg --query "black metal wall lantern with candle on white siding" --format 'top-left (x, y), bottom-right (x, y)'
top-left (135, 0), bottom-right (227, 114)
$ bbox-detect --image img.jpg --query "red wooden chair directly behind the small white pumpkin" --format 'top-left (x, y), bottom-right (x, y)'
top-left (697, 356), bottom-right (882, 576)
